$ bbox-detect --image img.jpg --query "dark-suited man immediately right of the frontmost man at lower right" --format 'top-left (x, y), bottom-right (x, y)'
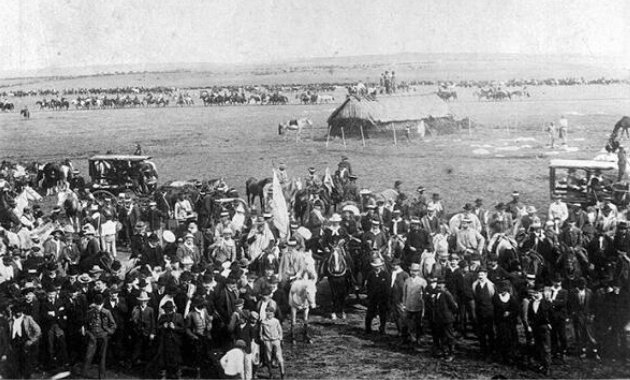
top-left (551, 273), bottom-right (569, 362)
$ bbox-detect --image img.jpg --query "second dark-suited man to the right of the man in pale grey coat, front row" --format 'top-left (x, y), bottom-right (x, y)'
top-left (431, 277), bottom-right (457, 362)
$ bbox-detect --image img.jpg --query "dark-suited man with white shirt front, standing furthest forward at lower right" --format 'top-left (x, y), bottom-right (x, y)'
top-left (527, 283), bottom-right (553, 377)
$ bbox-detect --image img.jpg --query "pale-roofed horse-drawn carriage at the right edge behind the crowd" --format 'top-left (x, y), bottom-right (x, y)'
top-left (549, 160), bottom-right (630, 206)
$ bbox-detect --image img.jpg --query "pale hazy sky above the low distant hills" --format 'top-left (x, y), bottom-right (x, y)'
top-left (0, 0), bottom-right (630, 71)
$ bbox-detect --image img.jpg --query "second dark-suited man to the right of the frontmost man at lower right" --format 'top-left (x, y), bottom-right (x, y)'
top-left (568, 277), bottom-right (599, 360)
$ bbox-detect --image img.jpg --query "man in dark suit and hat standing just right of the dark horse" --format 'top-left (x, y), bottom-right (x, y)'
top-left (365, 257), bottom-right (391, 335)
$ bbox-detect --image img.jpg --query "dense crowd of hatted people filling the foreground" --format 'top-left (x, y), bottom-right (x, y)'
top-left (0, 157), bottom-right (630, 379)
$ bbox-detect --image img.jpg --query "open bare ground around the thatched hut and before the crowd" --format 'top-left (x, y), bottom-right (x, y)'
top-left (0, 82), bottom-right (630, 379)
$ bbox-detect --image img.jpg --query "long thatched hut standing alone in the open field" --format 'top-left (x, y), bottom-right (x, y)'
top-left (328, 93), bottom-right (459, 143)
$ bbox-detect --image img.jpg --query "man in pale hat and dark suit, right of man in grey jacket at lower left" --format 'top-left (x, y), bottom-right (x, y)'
top-left (131, 291), bottom-right (156, 363)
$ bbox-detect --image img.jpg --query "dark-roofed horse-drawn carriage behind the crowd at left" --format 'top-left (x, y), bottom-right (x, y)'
top-left (88, 155), bottom-right (158, 203)
